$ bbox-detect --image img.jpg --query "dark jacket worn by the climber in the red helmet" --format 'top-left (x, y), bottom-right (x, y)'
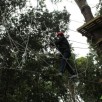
top-left (55, 36), bottom-right (71, 57)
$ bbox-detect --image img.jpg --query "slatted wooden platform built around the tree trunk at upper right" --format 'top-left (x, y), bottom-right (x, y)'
top-left (77, 16), bottom-right (102, 36)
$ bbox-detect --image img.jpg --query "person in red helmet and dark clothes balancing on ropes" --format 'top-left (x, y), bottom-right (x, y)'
top-left (54, 32), bottom-right (77, 78)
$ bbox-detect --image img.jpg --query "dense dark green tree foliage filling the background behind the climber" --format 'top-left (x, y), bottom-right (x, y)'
top-left (0, 0), bottom-right (102, 102)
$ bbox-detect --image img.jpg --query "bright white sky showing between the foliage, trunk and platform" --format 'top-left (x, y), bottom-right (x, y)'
top-left (31, 0), bottom-right (99, 57)
